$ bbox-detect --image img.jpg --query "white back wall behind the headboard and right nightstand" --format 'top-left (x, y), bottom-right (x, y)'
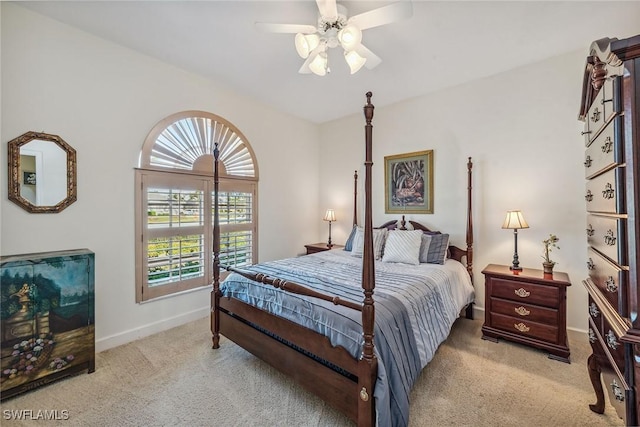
top-left (320, 51), bottom-right (588, 331)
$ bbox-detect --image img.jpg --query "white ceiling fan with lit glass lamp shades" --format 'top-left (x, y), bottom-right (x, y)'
top-left (255, 0), bottom-right (413, 76)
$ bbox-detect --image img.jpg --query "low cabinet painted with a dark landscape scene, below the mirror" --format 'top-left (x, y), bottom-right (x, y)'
top-left (0, 249), bottom-right (95, 400)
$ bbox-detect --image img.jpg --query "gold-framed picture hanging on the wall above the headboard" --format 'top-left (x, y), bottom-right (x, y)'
top-left (384, 150), bottom-right (433, 214)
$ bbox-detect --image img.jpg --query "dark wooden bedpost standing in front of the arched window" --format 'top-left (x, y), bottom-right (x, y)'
top-left (211, 142), bottom-right (220, 348)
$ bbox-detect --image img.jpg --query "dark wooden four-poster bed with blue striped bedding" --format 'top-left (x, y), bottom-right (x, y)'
top-left (211, 92), bottom-right (474, 426)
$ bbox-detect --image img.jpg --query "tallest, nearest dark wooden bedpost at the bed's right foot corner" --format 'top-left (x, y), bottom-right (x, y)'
top-left (358, 92), bottom-right (378, 426)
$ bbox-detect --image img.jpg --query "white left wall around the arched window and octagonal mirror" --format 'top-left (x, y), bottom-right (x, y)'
top-left (0, 3), bottom-right (319, 350)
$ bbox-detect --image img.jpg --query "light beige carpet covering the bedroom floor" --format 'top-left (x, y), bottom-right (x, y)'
top-left (1, 318), bottom-right (624, 427)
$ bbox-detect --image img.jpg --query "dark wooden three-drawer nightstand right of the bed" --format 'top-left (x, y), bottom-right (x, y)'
top-left (482, 264), bottom-right (571, 363)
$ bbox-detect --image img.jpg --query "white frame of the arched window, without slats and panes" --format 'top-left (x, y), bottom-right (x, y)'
top-left (135, 111), bottom-right (258, 303)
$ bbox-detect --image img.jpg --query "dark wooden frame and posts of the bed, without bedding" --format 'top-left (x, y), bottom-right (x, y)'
top-left (211, 92), bottom-right (473, 427)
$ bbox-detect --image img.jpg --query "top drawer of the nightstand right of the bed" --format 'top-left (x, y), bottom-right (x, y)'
top-left (491, 277), bottom-right (560, 308)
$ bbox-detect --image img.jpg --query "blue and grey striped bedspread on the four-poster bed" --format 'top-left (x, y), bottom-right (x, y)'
top-left (220, 249), bottom-right (474, 427)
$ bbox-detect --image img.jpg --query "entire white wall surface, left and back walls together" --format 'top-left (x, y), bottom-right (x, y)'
top-left (0, 3), bottom-right (632, 349)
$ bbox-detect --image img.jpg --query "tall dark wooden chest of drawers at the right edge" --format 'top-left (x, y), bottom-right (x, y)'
top-left (579, 35), bottom-right (640, 425)
